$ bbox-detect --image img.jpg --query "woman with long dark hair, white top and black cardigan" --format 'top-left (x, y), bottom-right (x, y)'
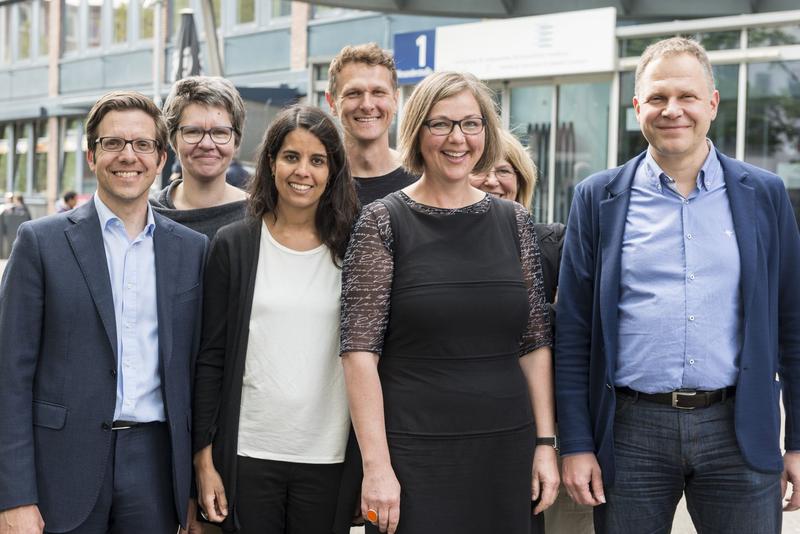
top-left (193, 106), bottom-right (358, 534)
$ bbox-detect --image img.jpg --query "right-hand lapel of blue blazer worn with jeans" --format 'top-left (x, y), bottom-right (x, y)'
top-left (717, 151), bottom-right (758, 323)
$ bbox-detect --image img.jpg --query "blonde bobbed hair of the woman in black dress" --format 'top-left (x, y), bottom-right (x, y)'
top-left (398, 72), bottom-right (502, 174)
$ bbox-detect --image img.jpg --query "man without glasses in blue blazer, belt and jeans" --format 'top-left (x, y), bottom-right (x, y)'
top-left (556, 38), bottom-right (800, 534)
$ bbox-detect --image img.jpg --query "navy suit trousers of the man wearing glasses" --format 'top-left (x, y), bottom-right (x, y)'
top-left (52, 423), bottom-right (178, 534)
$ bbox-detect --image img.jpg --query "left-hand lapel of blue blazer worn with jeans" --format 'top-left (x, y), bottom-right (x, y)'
top-left (595, 153), bottom-right (644, 376)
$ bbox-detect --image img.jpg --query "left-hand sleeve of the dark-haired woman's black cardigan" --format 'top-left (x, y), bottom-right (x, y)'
top-left (192, 234), bottom-right (230, 453)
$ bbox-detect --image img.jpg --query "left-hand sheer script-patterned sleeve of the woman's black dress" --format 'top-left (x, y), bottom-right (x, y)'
top-left (340, 202), bottom-right (394, 354)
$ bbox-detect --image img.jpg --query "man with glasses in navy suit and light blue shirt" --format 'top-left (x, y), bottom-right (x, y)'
top-left (0, 92), bottom-right (207, 534)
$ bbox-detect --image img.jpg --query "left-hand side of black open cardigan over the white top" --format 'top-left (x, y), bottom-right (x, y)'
top-left (192, 217), bottom-right (262, 531)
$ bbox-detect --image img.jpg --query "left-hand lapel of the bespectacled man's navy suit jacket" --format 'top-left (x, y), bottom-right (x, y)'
top-left (64, 199), bottom-right (119, 360)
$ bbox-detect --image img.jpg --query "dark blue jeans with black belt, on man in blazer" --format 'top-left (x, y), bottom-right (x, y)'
top-left (595, 394), bottom-right (781, 534)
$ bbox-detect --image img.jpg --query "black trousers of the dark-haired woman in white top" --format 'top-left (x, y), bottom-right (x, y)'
top-left (236, 456), bottom-right (342, 534)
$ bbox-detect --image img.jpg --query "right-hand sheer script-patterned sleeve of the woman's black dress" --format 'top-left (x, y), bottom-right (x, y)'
top-left (515, 204), bottom-right (553, 355)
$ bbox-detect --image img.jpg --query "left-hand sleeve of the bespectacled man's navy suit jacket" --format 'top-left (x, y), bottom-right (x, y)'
top-left (0, 224), bottom-right (45, 510)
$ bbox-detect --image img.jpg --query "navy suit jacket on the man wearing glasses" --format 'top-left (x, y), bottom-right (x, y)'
top-left (0, 201), bottom-right (207, 532)
